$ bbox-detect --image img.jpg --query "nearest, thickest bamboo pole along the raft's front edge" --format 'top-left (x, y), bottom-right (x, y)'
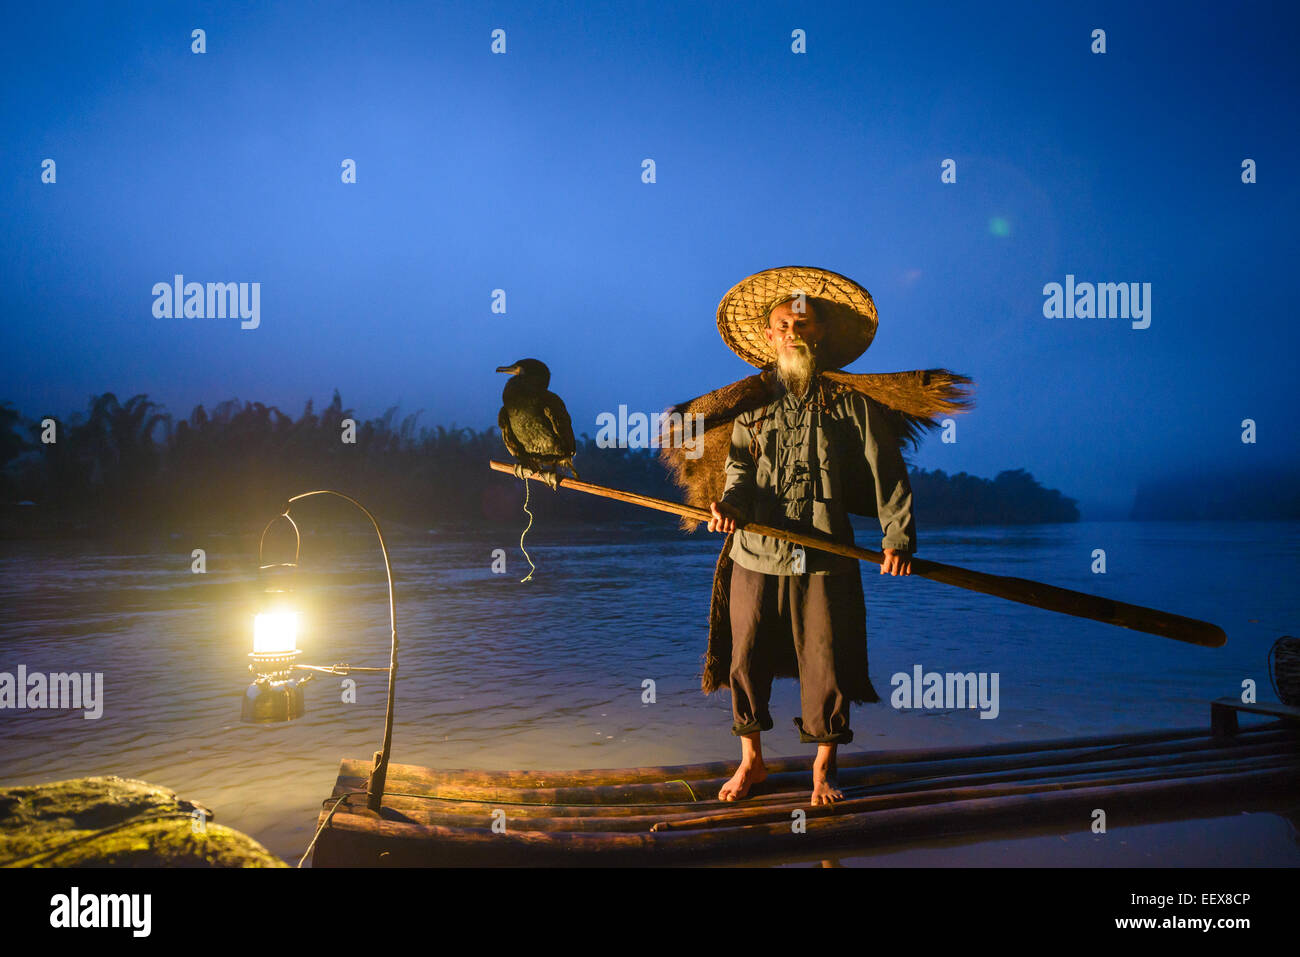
top-left (312, 767), bottom-right (1300, 867)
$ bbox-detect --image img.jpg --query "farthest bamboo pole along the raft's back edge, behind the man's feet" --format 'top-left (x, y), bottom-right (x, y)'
top-left (335, 729), bottom-right (1300, 806)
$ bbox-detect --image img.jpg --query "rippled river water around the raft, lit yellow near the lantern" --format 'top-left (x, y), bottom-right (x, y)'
top-left (0, 520), bottom-right (1300, 866)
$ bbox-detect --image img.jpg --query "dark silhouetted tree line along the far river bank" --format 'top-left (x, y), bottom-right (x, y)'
top-left (0, 390), bottom-right (1078, 534)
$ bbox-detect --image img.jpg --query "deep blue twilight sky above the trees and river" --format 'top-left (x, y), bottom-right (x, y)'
top-left (0, 3), bottom-right (1300, 507)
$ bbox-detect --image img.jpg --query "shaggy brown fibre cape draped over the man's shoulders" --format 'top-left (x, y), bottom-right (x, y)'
top-left (659, 367), bottom-right (974, 702)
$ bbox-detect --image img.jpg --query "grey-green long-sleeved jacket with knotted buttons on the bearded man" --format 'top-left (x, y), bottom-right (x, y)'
top-left (722, 389), bottom-right (917, 575)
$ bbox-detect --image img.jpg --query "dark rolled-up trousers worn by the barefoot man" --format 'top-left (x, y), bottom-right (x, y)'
top-left (731, 563), bottom-right (862, 744)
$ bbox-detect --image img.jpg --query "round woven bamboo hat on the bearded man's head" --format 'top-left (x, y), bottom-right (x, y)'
top-left (718, 265), bottom-right (878, 369)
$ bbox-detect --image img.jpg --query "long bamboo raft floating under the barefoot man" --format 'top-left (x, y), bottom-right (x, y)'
top-left (312, 698), bottom-right (1300, 867)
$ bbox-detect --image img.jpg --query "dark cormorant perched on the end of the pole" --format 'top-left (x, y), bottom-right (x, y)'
top-left (497, 359), bottom-right (579, 489)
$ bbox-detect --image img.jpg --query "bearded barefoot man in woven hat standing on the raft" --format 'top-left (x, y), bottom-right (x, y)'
top-left (709, 270), bottom-right (917, 806)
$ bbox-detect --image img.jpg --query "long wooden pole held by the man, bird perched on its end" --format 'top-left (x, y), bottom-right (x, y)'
top-left (489, 460), bottom-right (1227, 648)
